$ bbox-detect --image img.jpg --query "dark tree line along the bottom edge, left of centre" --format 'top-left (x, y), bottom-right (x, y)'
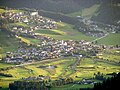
top-left (9, 78), bottom-right (73, 90)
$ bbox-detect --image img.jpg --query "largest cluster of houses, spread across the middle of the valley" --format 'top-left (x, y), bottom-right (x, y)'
top-left (3, 37), bottom-right (105, 63)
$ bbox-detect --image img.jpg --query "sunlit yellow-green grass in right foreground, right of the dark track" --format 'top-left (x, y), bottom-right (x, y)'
top-left (70, 58), bottom-right (120, 80)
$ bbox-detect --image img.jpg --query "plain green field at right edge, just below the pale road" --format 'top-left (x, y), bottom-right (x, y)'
top-left (97, 33), bottom-right (120, 45)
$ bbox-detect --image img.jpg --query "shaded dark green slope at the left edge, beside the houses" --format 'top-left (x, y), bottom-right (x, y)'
top-left (0, 30), bottom-right (19, 57)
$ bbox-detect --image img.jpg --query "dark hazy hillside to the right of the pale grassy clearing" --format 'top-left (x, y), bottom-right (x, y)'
top-left (92, 3), bottom-right (120, 24)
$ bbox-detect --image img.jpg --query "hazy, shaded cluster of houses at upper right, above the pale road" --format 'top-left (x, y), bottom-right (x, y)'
top-left (78, 17), bottom-right (120, 37)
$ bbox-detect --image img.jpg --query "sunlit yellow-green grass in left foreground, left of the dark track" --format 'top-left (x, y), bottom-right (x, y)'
top-left (0, 58), bottom-right (76, 87)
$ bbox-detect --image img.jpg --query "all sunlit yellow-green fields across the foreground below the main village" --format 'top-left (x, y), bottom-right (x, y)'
top-left (0, 57), bottom-right (120, 90)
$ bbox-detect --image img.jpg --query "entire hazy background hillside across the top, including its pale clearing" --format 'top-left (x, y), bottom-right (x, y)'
top-left (0, 0), bottom-right (120, 23)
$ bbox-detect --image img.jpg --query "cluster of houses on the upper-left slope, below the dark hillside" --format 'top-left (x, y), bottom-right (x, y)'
top-left (0, 10), bottom-right (57, 34)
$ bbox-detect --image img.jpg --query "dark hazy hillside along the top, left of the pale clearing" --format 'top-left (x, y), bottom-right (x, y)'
top-left (0, 0), bottom-right (98, 13)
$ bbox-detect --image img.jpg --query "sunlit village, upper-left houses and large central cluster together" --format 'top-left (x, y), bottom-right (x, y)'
top-left (0, 10), bottom-right (119, 64)
